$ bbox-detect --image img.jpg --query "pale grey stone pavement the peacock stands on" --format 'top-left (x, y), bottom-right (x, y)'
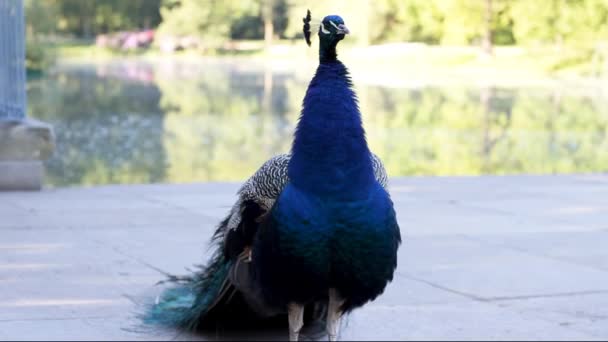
top-left (0, 175), bottom-right (608, 340)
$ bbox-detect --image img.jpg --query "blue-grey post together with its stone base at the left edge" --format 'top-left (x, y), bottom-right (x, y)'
top-left (0, 0), bottom-right (55, 190)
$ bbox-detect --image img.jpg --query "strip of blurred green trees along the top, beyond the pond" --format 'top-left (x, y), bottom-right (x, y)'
top-left (25, 0), bottom-right (608, 47)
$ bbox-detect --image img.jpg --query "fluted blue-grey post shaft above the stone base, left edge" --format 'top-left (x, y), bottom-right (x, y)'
top-left (0, 0), bottom-right (27, 120)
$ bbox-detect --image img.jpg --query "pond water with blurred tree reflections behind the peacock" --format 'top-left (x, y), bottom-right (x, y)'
top-left (28, 62), bottom-right (608, 186)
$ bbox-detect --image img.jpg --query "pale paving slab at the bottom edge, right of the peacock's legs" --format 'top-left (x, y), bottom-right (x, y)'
top-left (340, 302), bottom-right (598, 341)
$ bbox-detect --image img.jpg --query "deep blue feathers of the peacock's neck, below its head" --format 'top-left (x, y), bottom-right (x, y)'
top-left (288, 59), bottom-right (374, 197)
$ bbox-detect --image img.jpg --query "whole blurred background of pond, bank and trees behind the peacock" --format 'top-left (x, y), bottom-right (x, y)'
top-left (25, 0), bottom-right (608, 187)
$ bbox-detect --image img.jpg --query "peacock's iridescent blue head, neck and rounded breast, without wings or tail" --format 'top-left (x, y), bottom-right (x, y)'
top-left (253, 16), bottom-right (400, 311)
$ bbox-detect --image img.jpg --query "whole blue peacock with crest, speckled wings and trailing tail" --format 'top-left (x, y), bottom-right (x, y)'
top-left (145, 11), bottom-right (401, 341)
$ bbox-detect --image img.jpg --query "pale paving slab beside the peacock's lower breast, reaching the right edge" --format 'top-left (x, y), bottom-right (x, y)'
top-left (399, 237), bottom-right (608, 300)
